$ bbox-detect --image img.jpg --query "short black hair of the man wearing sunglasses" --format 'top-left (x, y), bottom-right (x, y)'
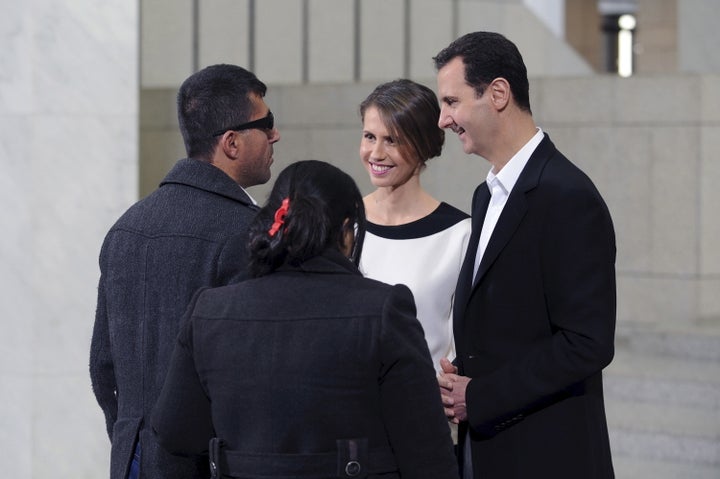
top-left (177, 64), bottom-right (267, 161)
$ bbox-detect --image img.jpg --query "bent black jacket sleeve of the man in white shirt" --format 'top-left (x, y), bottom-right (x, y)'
top-left (466, 180), bottom-right (616, 435)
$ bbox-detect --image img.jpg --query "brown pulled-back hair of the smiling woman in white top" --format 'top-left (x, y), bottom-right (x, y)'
top-left (360, 78), bottom-right (445, 165)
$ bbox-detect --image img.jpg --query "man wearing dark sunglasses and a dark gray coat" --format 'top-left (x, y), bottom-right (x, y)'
top-left (90, 65), bottom-right (280, 479)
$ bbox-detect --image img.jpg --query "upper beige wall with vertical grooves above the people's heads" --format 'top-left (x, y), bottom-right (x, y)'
top-left (140, 0), bottom-right (592, 88)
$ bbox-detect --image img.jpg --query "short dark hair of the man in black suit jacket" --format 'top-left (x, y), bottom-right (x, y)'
top-left (433, 32), bottom-right (532, 113)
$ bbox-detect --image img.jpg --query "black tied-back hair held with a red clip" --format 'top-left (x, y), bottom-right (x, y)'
top-left (248, 160), bottom-right (366, 277)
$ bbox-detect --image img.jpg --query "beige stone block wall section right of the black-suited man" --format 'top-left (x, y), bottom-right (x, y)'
top-left (535, 75), bottom-right (720, 323)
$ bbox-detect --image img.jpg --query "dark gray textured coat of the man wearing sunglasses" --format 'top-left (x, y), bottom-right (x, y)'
top-left (90, 159), bottom-right (257, 479)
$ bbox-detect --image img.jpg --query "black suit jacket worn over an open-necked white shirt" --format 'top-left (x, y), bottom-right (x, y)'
top-left (454, 135), bottom-right (615, 479)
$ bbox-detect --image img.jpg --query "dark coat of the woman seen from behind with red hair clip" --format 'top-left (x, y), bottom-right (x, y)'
top-left (152, 251), bottom-right (458, 479)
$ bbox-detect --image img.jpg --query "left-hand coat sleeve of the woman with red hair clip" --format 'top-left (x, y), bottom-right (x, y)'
top-left (150, 288), bottom-right (214, 456)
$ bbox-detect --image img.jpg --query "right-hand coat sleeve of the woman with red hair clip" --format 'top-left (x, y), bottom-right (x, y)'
top-left (380, 285), bottom-right (458, 479)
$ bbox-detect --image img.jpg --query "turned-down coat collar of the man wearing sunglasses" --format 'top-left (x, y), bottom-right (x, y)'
top-left (160, 158), bottom-right (257, 208)
